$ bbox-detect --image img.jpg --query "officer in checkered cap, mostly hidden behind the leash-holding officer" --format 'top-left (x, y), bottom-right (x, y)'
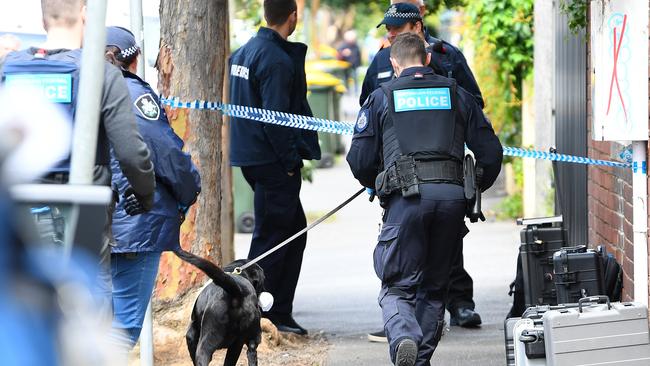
top-left (360, 4), bottom-right (483, 342)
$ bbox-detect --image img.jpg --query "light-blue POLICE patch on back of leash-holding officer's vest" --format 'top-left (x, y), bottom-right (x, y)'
top-left (393, 88), bottom-right (451, 112)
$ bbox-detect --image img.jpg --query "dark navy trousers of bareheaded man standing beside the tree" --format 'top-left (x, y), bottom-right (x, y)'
top-left (241, 163), bottom-right (307, 315)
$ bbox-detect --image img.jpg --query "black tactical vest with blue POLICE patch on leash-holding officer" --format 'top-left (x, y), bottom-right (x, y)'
top-left (381, 73), bottom-right (465, 169)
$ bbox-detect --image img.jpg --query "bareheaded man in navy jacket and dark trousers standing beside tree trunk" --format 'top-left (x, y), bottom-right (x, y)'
top-left (230, 0), bottom-right (320, 334)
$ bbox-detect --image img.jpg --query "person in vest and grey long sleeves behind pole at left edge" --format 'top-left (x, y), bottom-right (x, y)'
top-left (0, 0), bottom-right (155, 308)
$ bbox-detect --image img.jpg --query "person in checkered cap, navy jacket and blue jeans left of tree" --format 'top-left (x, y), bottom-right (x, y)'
top-left (106, 27), bottom-right (201, 348)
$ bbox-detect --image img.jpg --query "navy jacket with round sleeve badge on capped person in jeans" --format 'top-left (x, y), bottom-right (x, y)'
top-left (111, 71), bottom-right (201, 253)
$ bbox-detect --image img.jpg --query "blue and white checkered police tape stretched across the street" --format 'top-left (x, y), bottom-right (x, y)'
top-left (160, 97), bottom-right (632, 172)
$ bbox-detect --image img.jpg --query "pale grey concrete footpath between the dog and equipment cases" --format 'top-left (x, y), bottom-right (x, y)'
top-left (235, 161), bottom-right (519, 366)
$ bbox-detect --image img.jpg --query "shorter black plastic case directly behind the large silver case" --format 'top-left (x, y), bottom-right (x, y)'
top-left (553, 245), bottom-right (605, 304)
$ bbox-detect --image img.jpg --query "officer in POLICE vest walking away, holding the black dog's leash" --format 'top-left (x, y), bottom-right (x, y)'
top-left (347, 33), bottom-right (503, 366)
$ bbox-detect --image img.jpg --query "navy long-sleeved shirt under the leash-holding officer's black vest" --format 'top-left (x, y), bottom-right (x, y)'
top-left (347, 67), bottom-right (503, 190)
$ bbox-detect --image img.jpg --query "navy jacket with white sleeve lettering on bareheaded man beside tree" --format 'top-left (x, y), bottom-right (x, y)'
top-left (229, 27), bottom-right (320, 172)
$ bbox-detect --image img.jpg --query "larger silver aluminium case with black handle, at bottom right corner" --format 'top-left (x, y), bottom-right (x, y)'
top-left (542, 296), bottom-right (650, 366)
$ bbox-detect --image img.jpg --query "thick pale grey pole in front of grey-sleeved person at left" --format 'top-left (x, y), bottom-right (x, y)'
top-left (64, 0), bottom-right (106, 254)
